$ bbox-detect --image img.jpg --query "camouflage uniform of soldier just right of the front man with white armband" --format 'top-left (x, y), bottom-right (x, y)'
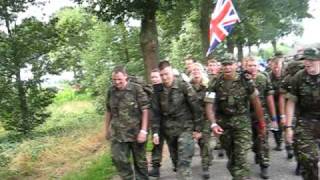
top-left (250, 72), bottom-right (274, 167)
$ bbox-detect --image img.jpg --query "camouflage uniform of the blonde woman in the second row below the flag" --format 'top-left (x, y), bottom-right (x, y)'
top-left (191, 82), bottom-right (213, 171)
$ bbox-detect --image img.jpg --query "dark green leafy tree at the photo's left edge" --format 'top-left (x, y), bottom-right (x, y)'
top-left (0, 0), bottom-right (60, 134)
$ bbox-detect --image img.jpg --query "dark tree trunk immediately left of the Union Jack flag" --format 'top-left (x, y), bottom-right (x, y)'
top-left (200, 0), bottom-right (213, 59)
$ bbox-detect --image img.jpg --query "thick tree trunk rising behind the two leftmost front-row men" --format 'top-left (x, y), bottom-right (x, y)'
top-left (140, 0), bottom-right (159, 82)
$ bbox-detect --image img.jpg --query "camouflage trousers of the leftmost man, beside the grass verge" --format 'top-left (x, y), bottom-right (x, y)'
top-left (111, 140), bottom-right (149, 180)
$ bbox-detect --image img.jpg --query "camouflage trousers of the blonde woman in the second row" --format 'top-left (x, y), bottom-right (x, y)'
top-left (198, 129), bottom-right (213, 170)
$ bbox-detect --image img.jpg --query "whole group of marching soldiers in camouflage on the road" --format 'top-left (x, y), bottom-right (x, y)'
top-left (105, 48), bottom-right (320, 180)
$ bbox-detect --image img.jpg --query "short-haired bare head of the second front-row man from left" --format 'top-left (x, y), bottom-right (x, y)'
top-left (159, 61), bottom-right (174, 87)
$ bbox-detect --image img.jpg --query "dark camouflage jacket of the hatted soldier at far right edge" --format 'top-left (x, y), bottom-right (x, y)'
top-left (287, 70), bottom-right (320, 119)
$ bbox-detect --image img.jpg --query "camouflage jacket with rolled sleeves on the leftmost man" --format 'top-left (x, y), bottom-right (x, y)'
top-left (106, 81), bottom-right (150, 142)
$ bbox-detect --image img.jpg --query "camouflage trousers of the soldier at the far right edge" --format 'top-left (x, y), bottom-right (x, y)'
top-left (294, 118), bottom-right (320, 180)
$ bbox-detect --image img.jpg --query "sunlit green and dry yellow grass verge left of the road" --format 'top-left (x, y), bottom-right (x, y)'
top-left (0, 87), bottom-right (114, 179)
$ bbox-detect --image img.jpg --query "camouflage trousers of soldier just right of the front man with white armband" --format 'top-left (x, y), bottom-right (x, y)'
top-left (251, 116), bottom-right (270, 167)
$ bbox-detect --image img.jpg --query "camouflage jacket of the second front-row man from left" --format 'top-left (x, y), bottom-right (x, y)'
top-left (152, 78), bottom-right (201, 136)
